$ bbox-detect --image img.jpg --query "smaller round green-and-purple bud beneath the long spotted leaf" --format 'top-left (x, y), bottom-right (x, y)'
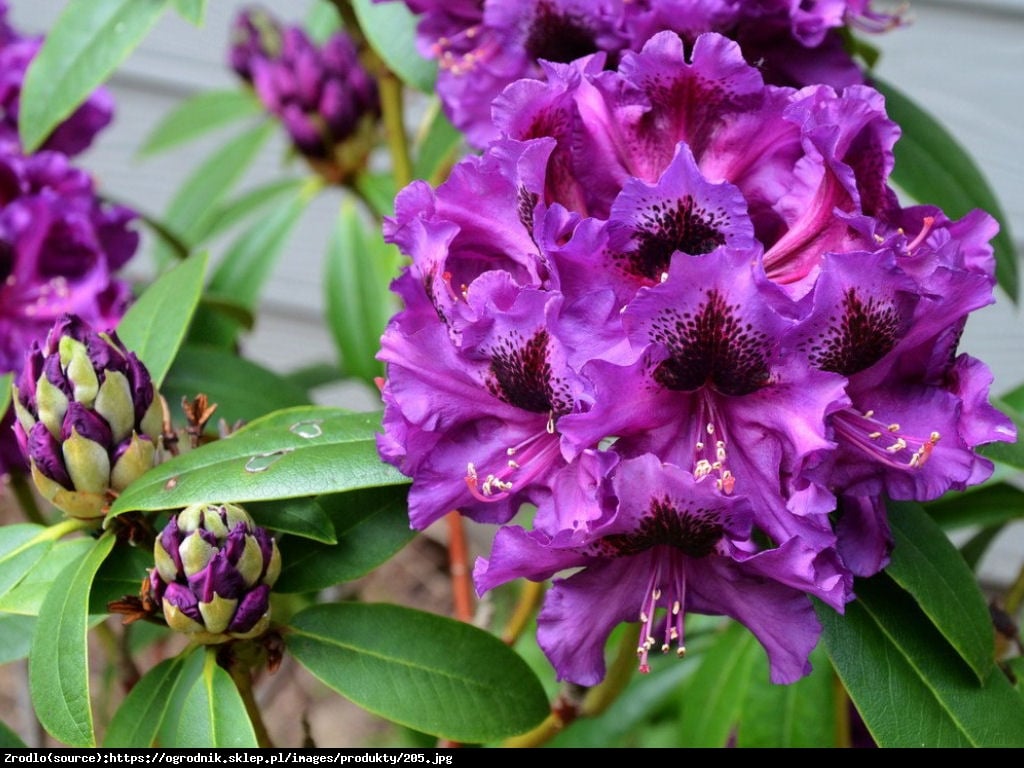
top-left (150, 503), bottom-right (281, 645)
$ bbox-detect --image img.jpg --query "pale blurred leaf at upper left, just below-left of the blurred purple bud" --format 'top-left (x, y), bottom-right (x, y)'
top-left (138, 88), bottom-right (263, 157)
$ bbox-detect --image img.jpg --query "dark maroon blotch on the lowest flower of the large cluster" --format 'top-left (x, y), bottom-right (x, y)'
top-left (593, 497), bottom-right (723, 557)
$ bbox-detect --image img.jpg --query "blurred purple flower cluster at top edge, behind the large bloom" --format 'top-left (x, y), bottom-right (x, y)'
top-left (376, 0), bottom-right (899, 147)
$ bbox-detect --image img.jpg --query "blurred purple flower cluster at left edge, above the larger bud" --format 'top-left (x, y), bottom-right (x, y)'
top-left (0, 5), bottom-right (139, 474)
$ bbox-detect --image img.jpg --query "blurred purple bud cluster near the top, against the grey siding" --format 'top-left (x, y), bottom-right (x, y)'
top-left (228, 7), bottom-right (380, 177)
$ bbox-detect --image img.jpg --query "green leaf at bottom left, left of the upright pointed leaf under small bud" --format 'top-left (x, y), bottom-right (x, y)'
top-left (103, 656), bottom-right (185, 749)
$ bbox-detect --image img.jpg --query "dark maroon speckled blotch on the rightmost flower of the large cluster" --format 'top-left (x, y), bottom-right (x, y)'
top-left (802, 288), bottom-right (903, 376)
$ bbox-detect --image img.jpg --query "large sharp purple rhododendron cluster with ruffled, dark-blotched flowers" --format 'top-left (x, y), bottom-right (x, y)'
top-left (378, 33), bottom-right (1015, 685)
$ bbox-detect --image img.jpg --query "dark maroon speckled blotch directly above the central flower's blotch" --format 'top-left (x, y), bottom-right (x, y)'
top-left (617, 195), bottom-right (727, 281)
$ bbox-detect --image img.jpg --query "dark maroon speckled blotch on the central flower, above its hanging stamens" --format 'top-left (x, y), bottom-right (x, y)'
top-left (650, 291), bottom-right (771, 395)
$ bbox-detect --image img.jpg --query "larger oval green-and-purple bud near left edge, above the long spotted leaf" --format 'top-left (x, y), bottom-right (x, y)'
top-left (13, 314), bottom-right (163, 519)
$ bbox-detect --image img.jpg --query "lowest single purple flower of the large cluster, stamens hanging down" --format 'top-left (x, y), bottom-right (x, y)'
top-left (474, 455), bottom-right (852, 685)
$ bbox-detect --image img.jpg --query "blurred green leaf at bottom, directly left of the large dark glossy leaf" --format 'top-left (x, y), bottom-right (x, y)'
top-left (736, 644), bottom-right (839, 749)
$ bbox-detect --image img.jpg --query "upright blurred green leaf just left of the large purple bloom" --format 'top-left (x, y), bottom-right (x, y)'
top-left (324, 199), bottom-right (398, 391)
